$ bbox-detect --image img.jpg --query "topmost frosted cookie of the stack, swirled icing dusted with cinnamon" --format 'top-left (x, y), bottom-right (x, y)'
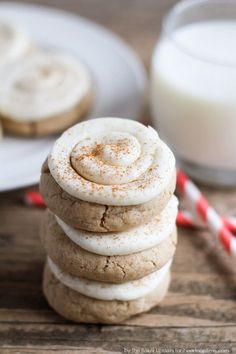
top-left (40, 118), bottom-right (176, 232)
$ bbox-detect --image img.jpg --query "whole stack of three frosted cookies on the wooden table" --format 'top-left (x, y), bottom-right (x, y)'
top-left (40, 118), bottom-right (178, 323)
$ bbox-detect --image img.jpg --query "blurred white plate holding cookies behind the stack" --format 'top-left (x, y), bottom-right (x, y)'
top-left (0, 3), bottom-right (147, 191)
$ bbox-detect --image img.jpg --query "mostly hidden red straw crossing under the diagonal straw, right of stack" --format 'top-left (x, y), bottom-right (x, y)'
top-left (176, 210), bottom-right (236, 233)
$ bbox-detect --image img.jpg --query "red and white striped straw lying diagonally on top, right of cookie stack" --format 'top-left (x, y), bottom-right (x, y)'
top-left (177, 170), bottom-right (236, 257)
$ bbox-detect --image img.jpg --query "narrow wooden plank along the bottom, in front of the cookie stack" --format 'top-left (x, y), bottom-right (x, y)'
top-left (0, 322), bottom-right (235, 346)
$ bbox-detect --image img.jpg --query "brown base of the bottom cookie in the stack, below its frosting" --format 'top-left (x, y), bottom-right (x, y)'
top-left (43, 264), bottom-right (170, 323)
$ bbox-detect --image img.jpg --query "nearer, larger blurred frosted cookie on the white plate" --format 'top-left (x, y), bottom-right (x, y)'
top-left (0, 52), bottom-right (91, 136)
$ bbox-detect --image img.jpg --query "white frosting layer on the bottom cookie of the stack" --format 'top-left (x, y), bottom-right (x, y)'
top-left (48, 257), bottom-right (172, 301)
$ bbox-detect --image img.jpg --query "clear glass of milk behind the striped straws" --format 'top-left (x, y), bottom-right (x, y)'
top-left (151, 0), bottom-right (236, 186)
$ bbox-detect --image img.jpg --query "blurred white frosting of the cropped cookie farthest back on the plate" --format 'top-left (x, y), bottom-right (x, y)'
top-left (0, 20), bottom-right (31, 67)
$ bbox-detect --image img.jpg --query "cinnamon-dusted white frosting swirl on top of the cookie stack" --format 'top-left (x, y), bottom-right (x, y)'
top-left (48, 118), bottom-right (175, 205)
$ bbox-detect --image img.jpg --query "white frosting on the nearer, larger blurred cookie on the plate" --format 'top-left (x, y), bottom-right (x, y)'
top-left (0, 52), bottom-right (91, 122)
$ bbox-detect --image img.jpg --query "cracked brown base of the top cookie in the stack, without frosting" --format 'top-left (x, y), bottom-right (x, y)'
top-left (40, 161), bottom-right (176, 232)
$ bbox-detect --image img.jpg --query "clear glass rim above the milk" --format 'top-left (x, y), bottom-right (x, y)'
top-left (162, 0), bottom-right (236, 68)
